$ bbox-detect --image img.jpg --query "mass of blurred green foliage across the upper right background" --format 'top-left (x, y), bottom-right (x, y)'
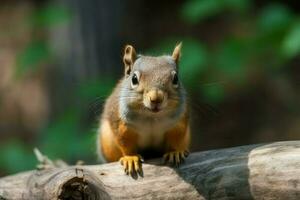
top-left (155, 0), bottom-right (300, 103)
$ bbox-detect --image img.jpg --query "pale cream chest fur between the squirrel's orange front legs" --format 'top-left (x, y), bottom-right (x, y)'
top-left (134, 119), bottom-right (175, 148)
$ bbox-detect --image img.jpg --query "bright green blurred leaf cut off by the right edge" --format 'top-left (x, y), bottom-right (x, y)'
top-left (282, 21), bottom-right (300, 58)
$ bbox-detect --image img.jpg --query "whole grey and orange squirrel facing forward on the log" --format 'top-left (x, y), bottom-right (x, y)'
top-left (97, 43), bottom-right (190, 174)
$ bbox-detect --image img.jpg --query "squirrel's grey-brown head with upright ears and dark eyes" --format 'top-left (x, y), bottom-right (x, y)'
top-left (120, 43), bottom-right (185, 119)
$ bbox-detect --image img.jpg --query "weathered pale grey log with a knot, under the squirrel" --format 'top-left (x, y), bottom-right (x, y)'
top-left (0, 141), bottom-right (300, 200)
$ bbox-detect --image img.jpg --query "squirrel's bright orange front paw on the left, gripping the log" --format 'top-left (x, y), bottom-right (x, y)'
top-left (120, 155), bottom-right (143, 175)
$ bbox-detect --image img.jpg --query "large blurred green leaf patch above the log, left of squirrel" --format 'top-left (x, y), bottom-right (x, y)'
top-left (39, 107), bottom-right (95, 162)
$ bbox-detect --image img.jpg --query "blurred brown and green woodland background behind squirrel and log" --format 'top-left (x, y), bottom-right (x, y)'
top-left (0, 0), bottom-right (300, 176)
